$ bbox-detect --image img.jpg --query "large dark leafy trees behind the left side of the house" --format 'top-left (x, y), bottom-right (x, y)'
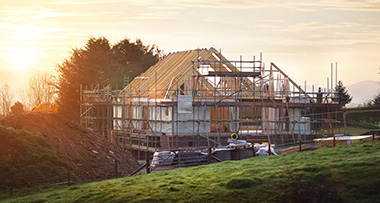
top-left (57, 37), bottom-right (160, 121)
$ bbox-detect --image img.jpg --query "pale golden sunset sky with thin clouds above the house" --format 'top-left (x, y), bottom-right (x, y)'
top-left (0, 0), bottom-right (380, 103)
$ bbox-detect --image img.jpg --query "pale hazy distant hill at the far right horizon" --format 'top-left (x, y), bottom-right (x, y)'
top-left (347, 80), bottom-right (380, 107)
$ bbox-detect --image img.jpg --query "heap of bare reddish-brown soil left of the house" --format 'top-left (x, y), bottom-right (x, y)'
top-left (0, 112), bottom-right (138, 181)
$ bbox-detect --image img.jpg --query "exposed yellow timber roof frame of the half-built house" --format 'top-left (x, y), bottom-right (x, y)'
top-left (121, 48), bottom-right (315, 103)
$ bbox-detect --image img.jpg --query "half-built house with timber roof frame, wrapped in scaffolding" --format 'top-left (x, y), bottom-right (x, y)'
top-left (81, 48), bottom-right (340, 157)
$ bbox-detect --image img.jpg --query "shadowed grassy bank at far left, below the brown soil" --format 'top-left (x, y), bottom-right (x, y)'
top-left (0, 126), bottom-right (75, 198)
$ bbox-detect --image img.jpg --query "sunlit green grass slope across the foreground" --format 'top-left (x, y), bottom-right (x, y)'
top-left (3, 141), bottom-right (380, 202)
